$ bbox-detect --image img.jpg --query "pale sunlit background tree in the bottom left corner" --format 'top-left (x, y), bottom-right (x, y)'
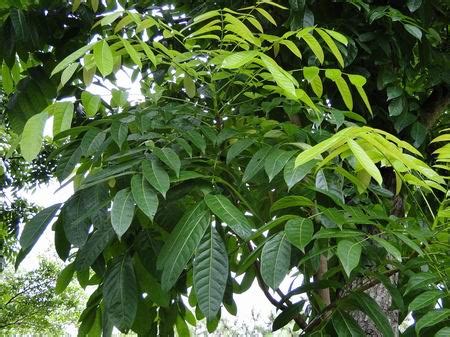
top-left (0, 260), bottom-right (84, 335)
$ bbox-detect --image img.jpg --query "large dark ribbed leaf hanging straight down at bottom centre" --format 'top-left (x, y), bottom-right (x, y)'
top-left (193, 227), bottom-right (228, 320)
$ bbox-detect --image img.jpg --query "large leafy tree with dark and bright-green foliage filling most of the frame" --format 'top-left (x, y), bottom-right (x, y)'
top-left (2, 1), bottom-right (450, 336)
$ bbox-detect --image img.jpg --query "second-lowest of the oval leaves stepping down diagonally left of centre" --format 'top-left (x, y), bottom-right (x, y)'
top-left (131, 175), bottom-right (159, 220)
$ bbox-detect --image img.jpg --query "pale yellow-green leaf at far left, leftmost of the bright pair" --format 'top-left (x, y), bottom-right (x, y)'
top-left (20, 111), bottom-right (48, 162)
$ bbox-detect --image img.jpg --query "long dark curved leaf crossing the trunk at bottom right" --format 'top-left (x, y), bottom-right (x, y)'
top-left (349, 292), bottom-right (394, 337)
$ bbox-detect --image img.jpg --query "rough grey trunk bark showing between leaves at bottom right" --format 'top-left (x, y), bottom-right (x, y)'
top-left (351, 275), bottom-right (399, 337)
